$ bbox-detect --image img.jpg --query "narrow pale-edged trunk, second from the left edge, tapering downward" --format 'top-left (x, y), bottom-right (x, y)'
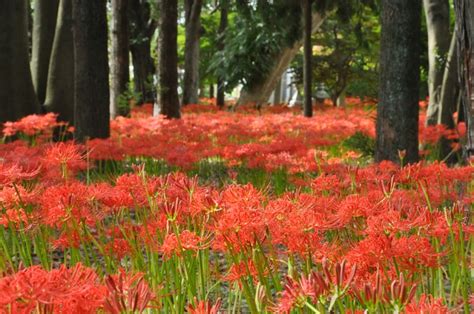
top-left (31, 0), bottom-right (59, 104)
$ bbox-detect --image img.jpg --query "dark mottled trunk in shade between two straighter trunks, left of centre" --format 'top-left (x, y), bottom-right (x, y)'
top-left (128, 0), bottom-right (157, 105)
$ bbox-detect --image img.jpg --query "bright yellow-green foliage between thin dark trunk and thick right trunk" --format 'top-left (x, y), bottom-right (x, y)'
top-left (292, 3), bottom-right (380, 101)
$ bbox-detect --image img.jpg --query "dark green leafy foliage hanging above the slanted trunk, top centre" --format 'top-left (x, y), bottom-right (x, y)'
top-left (210, 1), bottom-right (301, 90)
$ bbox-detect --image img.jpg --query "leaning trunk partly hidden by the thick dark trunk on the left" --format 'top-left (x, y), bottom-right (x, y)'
top-left (44, 0), bottom-right (74, 125)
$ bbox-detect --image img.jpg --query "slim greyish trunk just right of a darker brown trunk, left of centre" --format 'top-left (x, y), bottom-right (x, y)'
top-left (183, 0), bottom-right (202, 105)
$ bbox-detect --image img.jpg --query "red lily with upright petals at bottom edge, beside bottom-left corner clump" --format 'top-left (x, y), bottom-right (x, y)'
top-left (104, 270), bottom-right (155, 314)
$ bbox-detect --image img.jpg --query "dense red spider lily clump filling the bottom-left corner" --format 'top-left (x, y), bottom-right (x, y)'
top-left (0, 264), bottom-right (154, 313)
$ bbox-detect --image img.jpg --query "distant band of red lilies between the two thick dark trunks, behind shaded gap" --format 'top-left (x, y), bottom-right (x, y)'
top-left (89, 109), bottom-right (374, 172)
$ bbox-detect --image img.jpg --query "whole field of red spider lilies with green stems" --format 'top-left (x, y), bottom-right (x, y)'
top-left (0, 101), bottom-right (474, 313)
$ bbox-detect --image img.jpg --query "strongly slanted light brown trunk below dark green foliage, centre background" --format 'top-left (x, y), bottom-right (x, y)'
top-left (237, 12), bottom-right (325, 106)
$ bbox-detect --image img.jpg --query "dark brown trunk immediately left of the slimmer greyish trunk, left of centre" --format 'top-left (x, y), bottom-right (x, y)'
top-left (158, 0), bottom-right (181, 119)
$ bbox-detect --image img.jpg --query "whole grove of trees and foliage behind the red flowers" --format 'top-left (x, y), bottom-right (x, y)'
top-left (0, 0), bottom-right (474, 162)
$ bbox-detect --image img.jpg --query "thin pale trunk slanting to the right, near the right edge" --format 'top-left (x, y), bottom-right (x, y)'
top-left (437, 31), bottom-right (459, 163)
